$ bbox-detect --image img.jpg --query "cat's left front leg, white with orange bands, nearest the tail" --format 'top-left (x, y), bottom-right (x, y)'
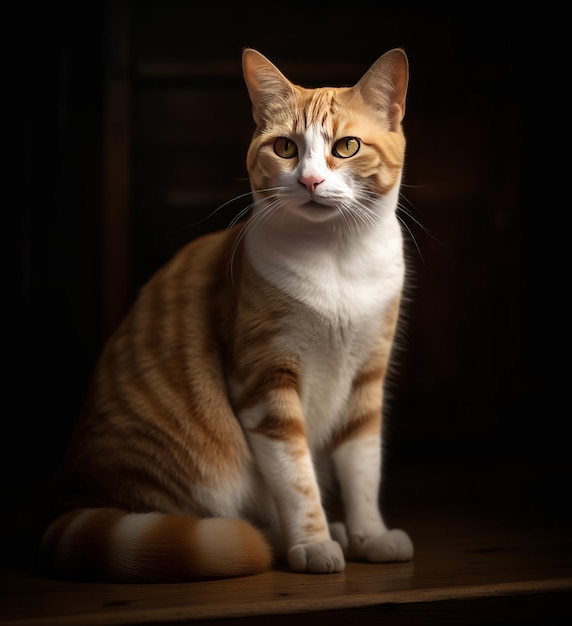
top-left (239, 374), bottom-right (345, 574)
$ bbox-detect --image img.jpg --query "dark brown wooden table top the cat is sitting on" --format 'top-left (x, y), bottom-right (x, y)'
top-left (0, 460), bottom-right (572, 626)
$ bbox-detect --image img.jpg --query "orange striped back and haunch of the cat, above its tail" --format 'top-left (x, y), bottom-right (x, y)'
top-left (53, 225), bottom-right (249, 511)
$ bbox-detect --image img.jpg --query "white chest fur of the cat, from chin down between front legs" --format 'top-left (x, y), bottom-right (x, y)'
top-left (246, 185), bottom-right (405, 438)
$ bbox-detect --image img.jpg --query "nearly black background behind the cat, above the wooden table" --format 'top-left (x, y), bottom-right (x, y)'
top-left (15, 0), bottom-right (570, 540)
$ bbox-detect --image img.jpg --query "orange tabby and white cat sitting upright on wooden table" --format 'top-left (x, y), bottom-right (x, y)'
top-left (41, 48), bottom-right (413, 582)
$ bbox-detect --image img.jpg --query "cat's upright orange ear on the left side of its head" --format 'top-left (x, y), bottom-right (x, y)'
top-left (242, 48), bottom-right (294, 127)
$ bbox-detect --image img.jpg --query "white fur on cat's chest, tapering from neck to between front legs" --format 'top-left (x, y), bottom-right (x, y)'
top-left (248, 216), bottom-right (404, 450)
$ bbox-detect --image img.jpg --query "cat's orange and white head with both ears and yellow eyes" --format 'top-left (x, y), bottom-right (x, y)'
top-left (243, 48), bottom-right (408, 223)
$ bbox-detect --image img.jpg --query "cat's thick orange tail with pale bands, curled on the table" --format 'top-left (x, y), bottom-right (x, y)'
top-left (41, 509), bottom-right (272, 583)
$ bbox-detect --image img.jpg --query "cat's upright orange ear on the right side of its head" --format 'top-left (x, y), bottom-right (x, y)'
top-left (354, 48), bottom-right (409, 129)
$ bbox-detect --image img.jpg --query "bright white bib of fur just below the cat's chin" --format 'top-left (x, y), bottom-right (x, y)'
top-left (246, 193), bottom-right (404, 316)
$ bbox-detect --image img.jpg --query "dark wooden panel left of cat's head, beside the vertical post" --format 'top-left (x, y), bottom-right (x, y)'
top-left (131, 84), bottom-right (254, 289)
